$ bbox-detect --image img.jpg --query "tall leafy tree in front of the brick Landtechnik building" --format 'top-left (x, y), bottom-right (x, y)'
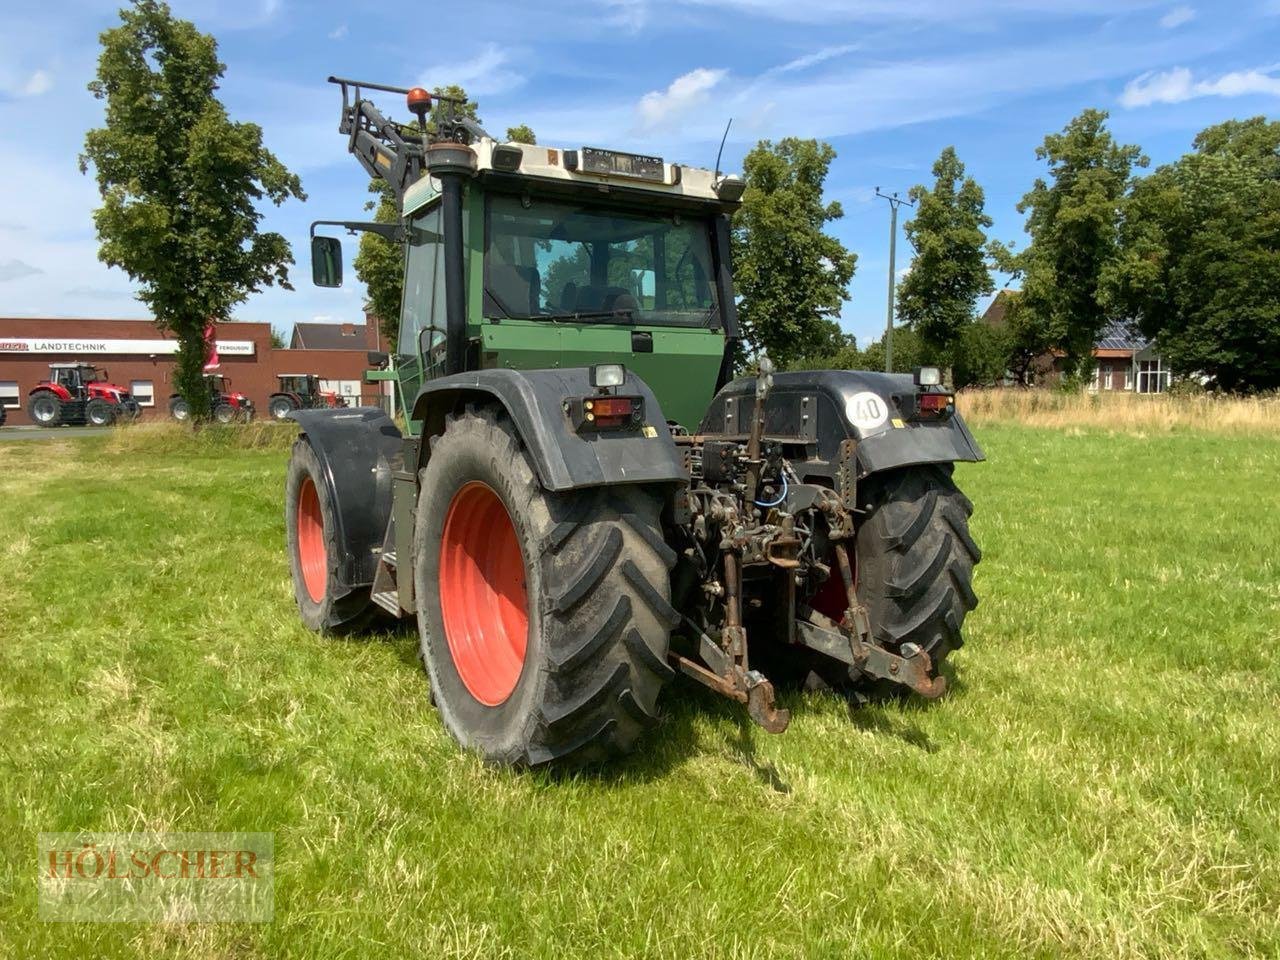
top-left (81, 0), bottom-right (306, 417)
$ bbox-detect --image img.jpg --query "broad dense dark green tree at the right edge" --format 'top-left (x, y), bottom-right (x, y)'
top-left (1107, 116), bottom-right (1280, 390)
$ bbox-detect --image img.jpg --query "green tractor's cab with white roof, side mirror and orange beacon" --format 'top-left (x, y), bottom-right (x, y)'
top-left (312, 81), bottom-right (744, 433)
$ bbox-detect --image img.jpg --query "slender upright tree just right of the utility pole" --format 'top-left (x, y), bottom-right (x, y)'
top-left (897, 147), bottom-right (995, 365)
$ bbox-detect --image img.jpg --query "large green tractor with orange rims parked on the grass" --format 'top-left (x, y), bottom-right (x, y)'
top-left (284, 78), bottom-right (983, 765)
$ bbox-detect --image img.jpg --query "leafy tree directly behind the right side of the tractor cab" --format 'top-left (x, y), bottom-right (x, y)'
top-left (732, 137), bottom-right (858, 366)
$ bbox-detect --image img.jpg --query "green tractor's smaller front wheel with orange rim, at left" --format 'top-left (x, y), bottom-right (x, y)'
top-left (284, 438), bottom-right (379, 634)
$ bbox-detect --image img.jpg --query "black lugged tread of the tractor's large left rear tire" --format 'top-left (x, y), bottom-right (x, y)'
top-left (420, 404), bottom-right (678, 768)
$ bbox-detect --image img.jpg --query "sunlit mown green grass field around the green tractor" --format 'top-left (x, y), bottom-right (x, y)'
top-left (0, 424), bottom-right (1280, 960)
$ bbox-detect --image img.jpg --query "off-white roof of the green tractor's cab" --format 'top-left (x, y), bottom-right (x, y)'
top-left (404, 137), bottom-right (742, 214)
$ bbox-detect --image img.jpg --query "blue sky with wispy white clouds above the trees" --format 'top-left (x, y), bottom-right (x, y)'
top-left (0, 0), bottom-right (1280, 346)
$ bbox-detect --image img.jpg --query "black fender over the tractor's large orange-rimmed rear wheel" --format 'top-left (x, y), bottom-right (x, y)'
top-left (412, 367), bottom-right (687, 490)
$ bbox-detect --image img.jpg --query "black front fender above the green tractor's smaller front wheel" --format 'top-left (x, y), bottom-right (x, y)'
top-left (289, 407), bottom-right (401, 599)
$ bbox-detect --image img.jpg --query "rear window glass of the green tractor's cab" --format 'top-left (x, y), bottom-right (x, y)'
top-left (485, 196), bottom-right (719, 326)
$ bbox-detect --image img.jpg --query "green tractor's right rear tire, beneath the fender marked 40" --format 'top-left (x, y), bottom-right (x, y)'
top-left (856, 465), bottom-right (982, 672)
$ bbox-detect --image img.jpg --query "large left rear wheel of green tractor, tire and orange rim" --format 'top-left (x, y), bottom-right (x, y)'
top-left (413, 408), bottom-right (677, 765)
